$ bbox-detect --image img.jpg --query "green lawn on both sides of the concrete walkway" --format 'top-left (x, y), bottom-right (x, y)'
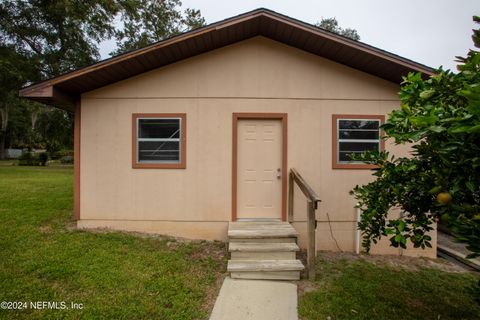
top-left (0, 162), bottom-right (480, 320)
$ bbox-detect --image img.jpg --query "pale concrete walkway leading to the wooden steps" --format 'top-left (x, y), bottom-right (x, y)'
top-left (210, 277), bottom-right (298, 320)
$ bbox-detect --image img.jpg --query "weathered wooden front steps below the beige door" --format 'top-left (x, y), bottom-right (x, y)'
top-left (227, 221), bottom-right (304, 280)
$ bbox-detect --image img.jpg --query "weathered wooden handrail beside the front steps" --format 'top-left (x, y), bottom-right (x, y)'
top-left (288, 168), bottom-right (322, 281)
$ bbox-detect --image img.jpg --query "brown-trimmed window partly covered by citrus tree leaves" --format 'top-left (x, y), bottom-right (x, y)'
top-left (332, 115), bottom-right (385, 169)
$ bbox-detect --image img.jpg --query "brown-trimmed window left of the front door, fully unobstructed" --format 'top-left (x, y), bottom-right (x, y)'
top-left (132, 113), bottom-right (186, 169)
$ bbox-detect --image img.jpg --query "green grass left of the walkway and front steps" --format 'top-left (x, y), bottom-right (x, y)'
top-left (0, 165), bottom-right (225, 319)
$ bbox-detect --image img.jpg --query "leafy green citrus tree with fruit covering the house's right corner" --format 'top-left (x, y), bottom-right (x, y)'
top-left (351, 17), bottom-right (480, 294)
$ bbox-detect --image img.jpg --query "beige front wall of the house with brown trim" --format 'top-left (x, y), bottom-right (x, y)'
top-left (79, 37), bottom-right (435, 256)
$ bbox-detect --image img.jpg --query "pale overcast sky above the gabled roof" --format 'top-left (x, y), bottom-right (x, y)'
top-left (100, 0), bottom-right (480, 70)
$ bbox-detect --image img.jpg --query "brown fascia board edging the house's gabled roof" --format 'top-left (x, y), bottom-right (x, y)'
top-left (19, 8), bottom-right (435, 110)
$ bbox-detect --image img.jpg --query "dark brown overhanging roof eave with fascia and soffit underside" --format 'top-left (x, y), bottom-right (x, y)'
top-left (20, 8), bottom-right (435, 107)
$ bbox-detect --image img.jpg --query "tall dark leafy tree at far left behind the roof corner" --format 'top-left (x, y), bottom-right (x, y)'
top-left (0, 0), bottom-right (124, 154)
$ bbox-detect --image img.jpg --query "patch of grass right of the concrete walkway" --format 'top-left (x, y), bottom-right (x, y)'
top-left (299, 255), bottom-right (480, 320)
